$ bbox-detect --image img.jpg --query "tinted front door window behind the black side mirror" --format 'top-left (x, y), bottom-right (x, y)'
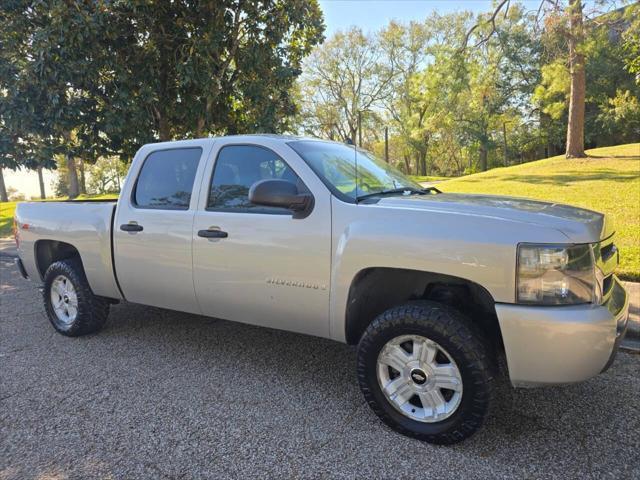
top-left (207, 145), bottom-right (304, 213)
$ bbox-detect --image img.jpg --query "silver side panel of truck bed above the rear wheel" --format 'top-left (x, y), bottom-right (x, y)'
top-left (16, 199), bottom-right (122, 299)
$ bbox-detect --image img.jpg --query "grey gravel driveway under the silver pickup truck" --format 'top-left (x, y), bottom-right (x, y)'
top-left (0, 258), bottom-right (640, 479)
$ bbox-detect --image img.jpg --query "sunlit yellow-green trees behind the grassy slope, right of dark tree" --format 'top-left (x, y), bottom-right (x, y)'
top-left (298, 4), bottom-right (640, 175)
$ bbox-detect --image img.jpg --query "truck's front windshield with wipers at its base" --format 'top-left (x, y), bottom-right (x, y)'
top-left (289, 140), bottom-right (422, 200)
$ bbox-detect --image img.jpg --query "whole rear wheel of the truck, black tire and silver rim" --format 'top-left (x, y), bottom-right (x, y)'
top-left (43, 258), bottom-right (109, 337)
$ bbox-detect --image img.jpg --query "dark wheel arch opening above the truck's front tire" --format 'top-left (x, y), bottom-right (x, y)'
top-left (345, 267), bottom-right (502, 348)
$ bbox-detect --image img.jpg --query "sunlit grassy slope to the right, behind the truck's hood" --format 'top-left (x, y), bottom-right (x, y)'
top-left (438, 143), bottom-right (640, 281)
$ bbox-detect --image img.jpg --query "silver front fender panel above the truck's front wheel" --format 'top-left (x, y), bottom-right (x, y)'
top-left (330, 200), bottom-right (567, 342)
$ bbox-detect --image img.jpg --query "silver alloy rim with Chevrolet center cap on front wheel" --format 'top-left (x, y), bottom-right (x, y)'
top-left (377, 335), bottom-right (462, 423)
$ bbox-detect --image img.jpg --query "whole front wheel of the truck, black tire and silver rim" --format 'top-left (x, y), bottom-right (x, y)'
top-left (358, 301), bottom-right (494, 445)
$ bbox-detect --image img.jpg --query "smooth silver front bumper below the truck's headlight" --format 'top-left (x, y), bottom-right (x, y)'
top-left (496, 275), bottom-right (629, 387)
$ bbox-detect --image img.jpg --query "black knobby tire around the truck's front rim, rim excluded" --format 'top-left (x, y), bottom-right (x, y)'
top-left (357, 301), bottom-right (494, 445)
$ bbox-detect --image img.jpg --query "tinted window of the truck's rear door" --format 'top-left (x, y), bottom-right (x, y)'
top-left (134, 148), bottom-right (202, 210)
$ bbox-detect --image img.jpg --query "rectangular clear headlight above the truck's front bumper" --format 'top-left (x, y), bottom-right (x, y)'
top-left (516, 244), bottom-right (596, 305)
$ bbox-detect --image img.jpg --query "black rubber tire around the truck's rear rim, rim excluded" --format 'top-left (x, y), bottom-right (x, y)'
top-left (42, 258), bottom-right (109, 337)
